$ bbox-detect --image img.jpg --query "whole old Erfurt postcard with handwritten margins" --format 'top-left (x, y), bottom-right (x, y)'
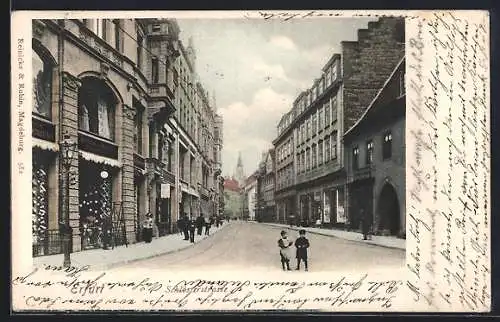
top-left (10, 10), bottom-right (491, 313)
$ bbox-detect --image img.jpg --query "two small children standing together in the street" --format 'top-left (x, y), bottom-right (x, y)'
top-left (278, 229), bottom-right (309, 271)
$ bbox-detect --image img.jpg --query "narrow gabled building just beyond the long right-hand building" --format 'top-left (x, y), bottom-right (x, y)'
top-left (255, 148), bottom-right (277, 222)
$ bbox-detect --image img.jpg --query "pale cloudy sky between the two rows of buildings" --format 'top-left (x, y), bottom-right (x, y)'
top-left (178, 18), bottom-right (374, 180)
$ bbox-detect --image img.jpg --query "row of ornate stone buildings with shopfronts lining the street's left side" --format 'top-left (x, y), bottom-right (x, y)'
top-left (28, 19), bottom-right (222, 256)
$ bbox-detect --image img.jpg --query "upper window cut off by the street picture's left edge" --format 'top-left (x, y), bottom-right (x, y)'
top-left (32, 46), bottom-right (52, 119)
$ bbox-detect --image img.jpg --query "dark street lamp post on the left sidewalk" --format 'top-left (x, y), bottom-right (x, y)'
top-left (59, 135), bottom-right (78, 267)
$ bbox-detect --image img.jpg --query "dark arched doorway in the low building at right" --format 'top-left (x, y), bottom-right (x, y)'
top-left (377, 183), bottom-right (401, 235)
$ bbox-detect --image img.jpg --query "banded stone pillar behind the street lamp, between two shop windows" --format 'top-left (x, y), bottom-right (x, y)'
top-left (59, 72), bottom-right (81, 252)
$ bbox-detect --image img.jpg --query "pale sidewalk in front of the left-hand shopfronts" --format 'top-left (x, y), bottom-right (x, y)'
top-left (33, 222), bottom-right (230, 270)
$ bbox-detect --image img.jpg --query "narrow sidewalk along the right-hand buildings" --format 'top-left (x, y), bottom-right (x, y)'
top-left (260, 223), bottom-right (406, 250)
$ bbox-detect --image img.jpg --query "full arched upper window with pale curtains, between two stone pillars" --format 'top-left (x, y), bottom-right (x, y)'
top-left (78, 77), bottom-right (117, 140)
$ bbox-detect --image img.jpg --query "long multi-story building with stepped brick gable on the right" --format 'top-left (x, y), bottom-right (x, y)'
top-left (273, 17), bottom-right (404, 229)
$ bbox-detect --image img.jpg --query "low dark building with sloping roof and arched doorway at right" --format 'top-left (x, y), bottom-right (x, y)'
top-left (344, 58), bottom-right (406, 237)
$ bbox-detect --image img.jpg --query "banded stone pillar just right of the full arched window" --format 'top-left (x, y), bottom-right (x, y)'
top-left (121, 104), bottom-right (137, 243)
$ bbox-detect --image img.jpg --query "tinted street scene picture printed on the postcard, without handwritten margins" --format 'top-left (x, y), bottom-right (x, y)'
top-left (27, 15), bottom-right (406, 276)
